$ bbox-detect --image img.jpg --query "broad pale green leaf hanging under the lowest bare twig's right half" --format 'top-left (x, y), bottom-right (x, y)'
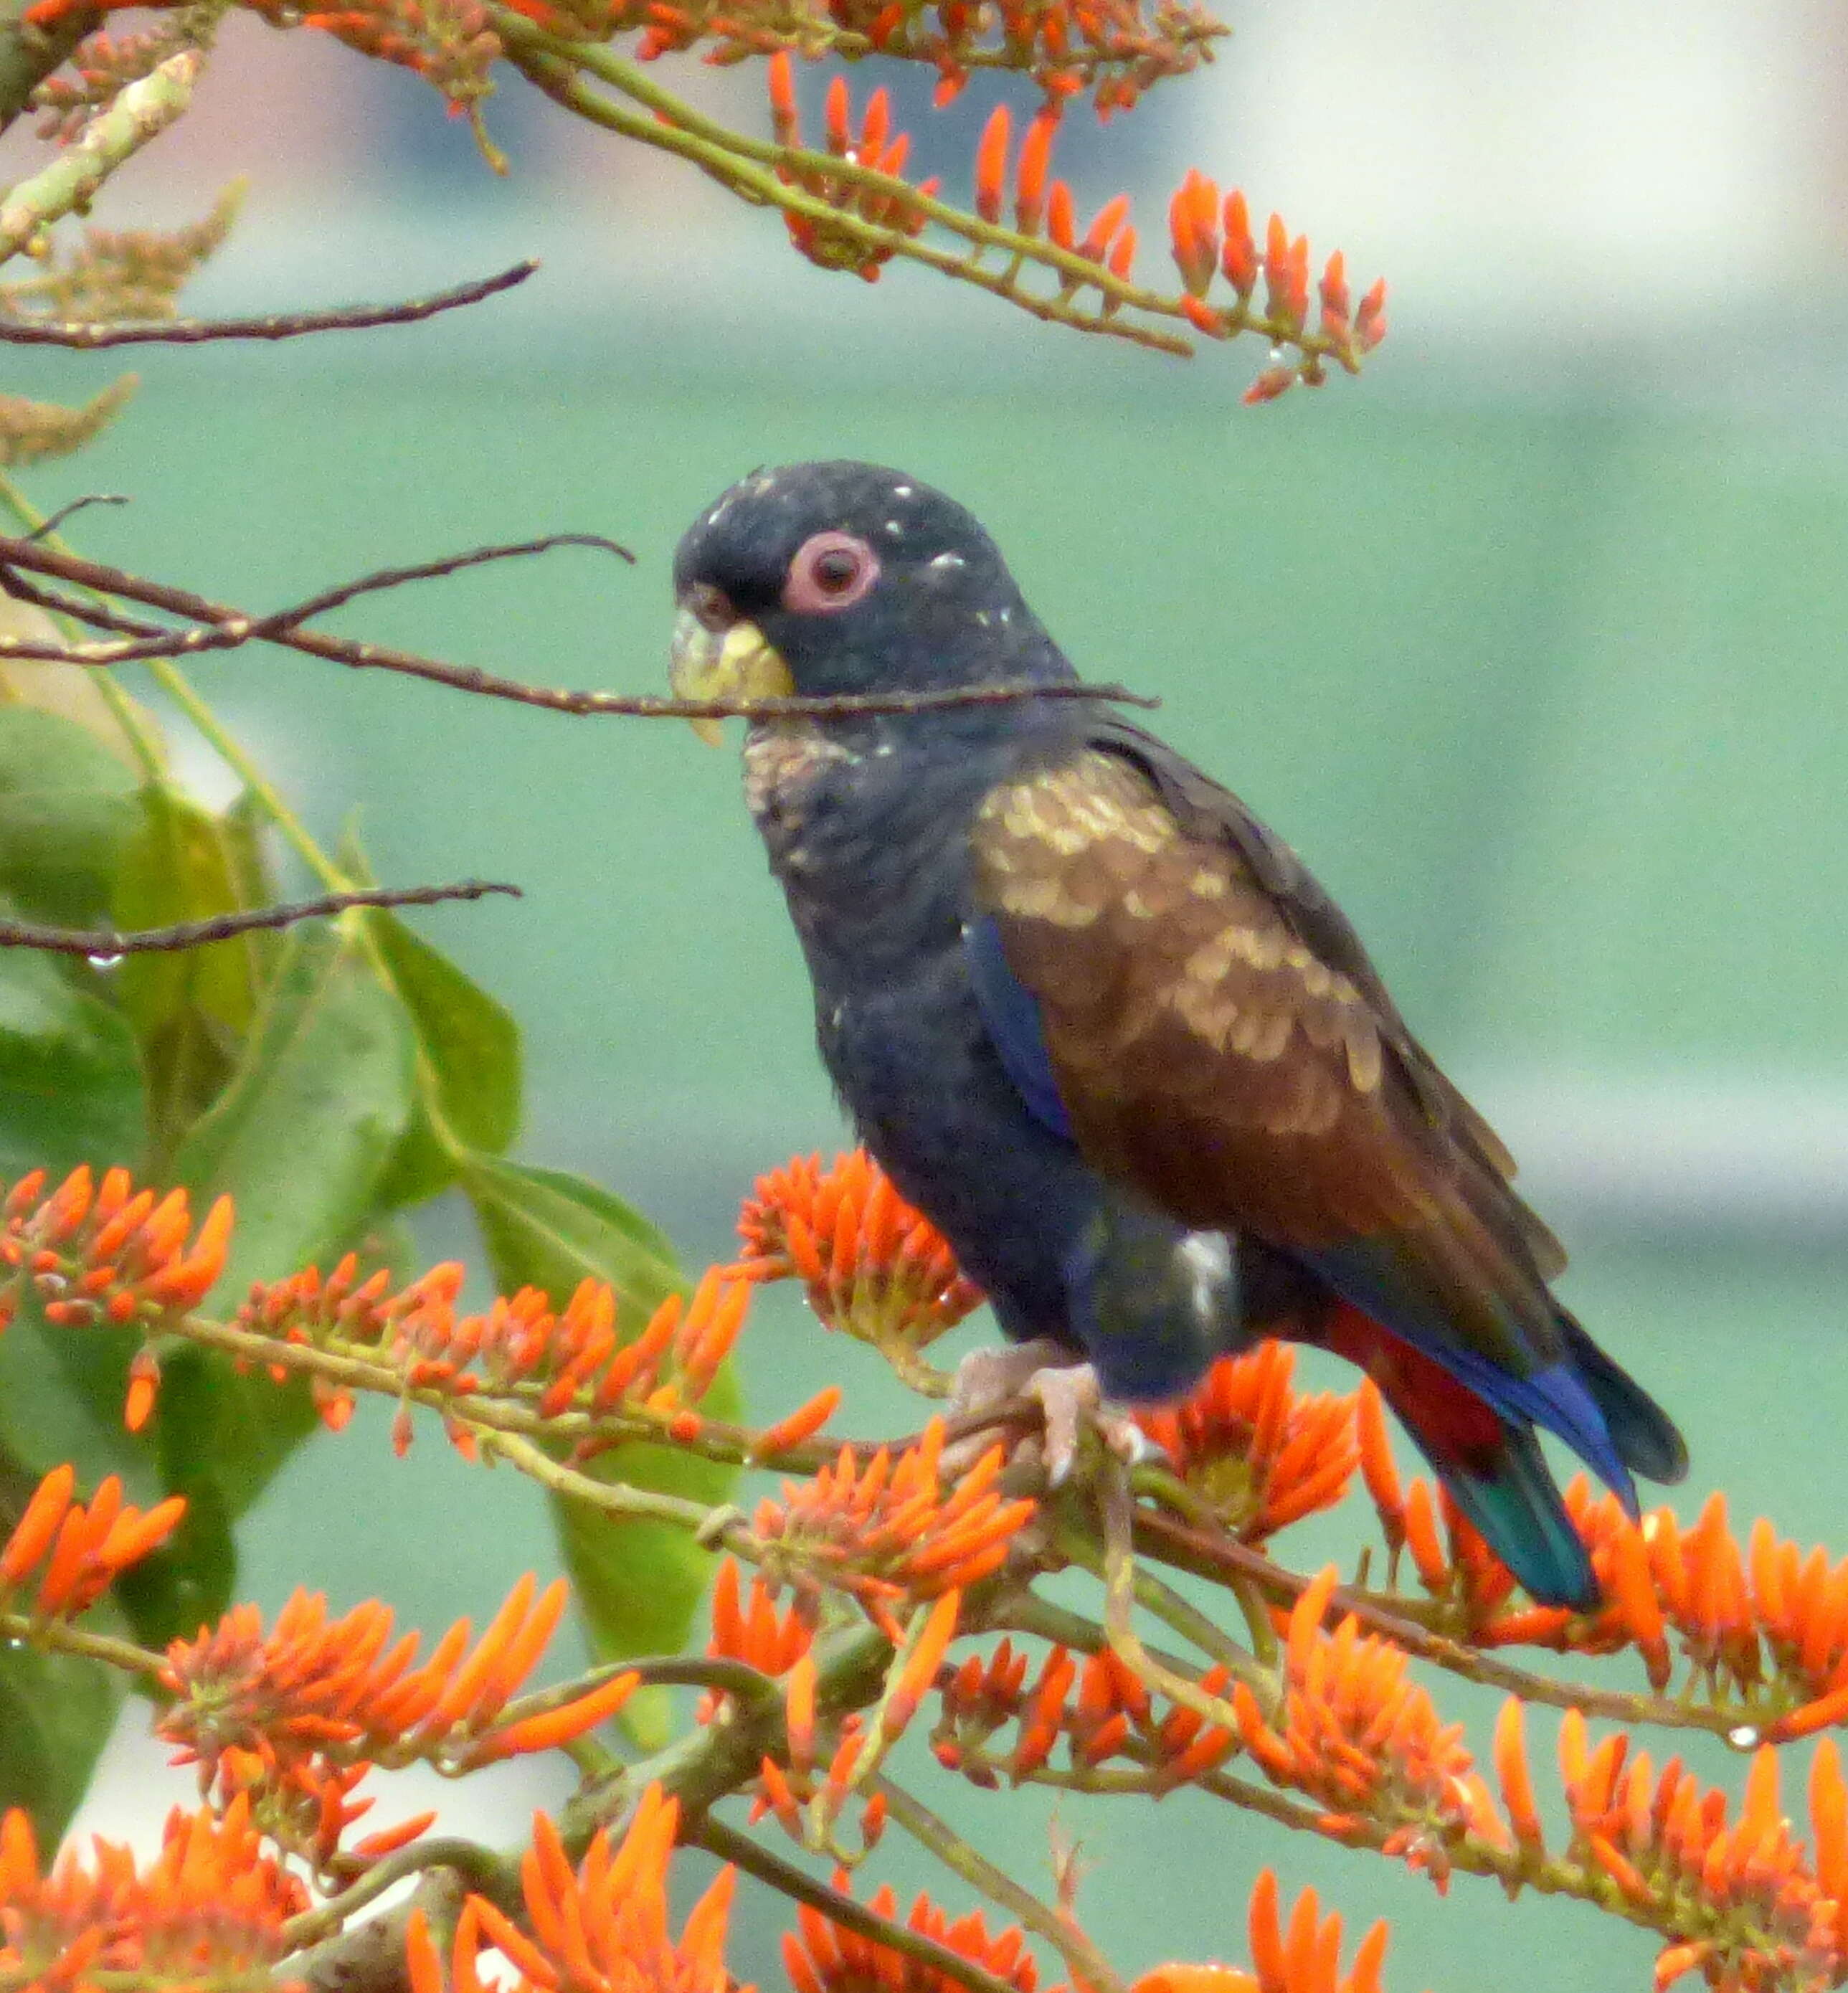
top-left (176, 919), bottom-right (412, 1294)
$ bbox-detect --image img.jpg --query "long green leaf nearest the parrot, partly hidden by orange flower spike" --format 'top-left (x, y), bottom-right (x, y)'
top-left (463, 1156), bottom-right (738, 1748)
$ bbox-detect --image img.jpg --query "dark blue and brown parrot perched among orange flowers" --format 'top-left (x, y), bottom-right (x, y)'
top-left (672, 463), bottom-right (1687, 1606)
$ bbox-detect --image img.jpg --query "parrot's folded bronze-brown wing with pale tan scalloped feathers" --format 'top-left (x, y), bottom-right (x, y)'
top-left (973, 727), bottom-right (1561, 1369)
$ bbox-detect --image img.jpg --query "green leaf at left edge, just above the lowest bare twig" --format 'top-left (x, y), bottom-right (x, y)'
top-left (0, 706), bottom-right (136, 927)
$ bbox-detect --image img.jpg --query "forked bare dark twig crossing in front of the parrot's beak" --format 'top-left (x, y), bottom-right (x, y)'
top-left (0, 534), bottom-right (1160, 719)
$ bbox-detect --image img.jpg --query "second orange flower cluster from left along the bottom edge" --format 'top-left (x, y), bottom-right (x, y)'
top-left (404, 1786), bottom-right (752, 1993)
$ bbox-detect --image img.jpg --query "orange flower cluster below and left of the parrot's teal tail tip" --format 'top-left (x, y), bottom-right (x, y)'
top-left (1232, 1566), bottom-right (1503, 1885)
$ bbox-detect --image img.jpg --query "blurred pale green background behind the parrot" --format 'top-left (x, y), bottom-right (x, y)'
top-left (10, 19), bottom-right (1848, 1993)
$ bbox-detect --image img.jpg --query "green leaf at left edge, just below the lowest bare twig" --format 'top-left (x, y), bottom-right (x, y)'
top-left (0, 949), bottom-right (148, 1182)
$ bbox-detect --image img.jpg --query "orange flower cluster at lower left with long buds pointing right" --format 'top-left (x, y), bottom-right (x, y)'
top-left (158, 1574), bottom-right (636, 1862)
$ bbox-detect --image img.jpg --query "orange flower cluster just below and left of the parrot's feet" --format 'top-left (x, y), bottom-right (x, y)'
top-left (752, 1419), bottom-right (1035, 1624)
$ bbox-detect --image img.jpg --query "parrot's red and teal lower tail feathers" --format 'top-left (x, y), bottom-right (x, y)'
top-left (1316, 1302), bottom-right (1603, 1609)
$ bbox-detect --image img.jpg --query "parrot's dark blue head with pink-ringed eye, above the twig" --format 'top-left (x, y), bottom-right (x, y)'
top-left (674, 463), bottom-right (1071, 725)
